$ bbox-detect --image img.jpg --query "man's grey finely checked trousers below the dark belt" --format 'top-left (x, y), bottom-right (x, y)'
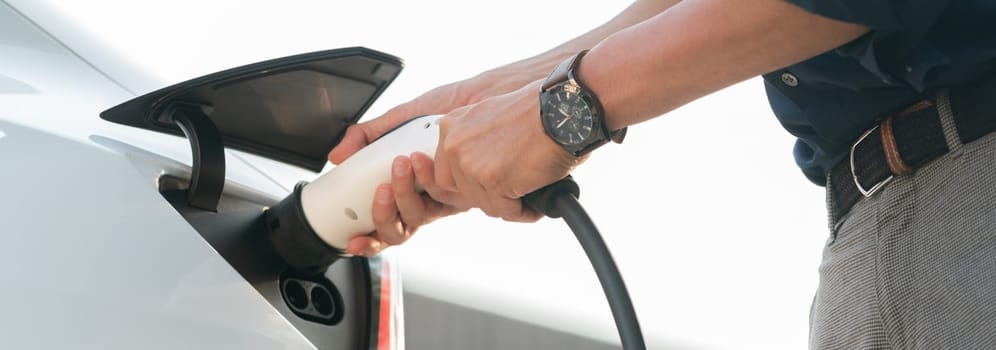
top-left (810, 93), bottom-right (996, 349)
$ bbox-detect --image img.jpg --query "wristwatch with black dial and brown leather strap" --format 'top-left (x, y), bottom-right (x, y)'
top-left (540, 50), bottom-right (626, 157)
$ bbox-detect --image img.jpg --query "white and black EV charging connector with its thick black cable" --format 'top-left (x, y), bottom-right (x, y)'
top-left (266, 116), bottom-right (646, 350)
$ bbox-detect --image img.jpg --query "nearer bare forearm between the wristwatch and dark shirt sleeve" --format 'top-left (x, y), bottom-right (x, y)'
top-left (579, 0), bottom-right (867, 130)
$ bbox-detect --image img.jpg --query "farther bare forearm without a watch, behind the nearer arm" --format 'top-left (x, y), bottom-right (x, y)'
top-left (474, 0), bottom-right (681, 84)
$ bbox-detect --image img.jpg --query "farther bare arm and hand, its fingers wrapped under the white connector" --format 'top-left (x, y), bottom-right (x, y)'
top-left (338, 0), bottom-right (678, 255)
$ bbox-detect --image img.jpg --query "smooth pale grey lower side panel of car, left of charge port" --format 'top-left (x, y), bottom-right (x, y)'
top-left (0, 122), bottom-right (312, 349)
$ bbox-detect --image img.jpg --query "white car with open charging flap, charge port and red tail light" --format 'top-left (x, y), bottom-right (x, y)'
top-left (0, 3), bottom-right (403, 349)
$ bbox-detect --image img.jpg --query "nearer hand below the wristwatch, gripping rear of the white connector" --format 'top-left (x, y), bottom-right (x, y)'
top-left (435, 81), bottom-right (584, 222)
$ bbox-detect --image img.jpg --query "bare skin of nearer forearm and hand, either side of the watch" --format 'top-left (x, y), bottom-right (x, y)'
top-left (436, 0), bottom-right (867, 221)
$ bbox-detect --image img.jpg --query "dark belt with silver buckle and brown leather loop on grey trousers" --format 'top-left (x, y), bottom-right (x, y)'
top-left (828, 77), bottom-right (996, 222)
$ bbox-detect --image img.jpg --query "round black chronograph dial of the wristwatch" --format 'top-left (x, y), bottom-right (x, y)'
top-left (542, 90), bottom-right (595, 145)
